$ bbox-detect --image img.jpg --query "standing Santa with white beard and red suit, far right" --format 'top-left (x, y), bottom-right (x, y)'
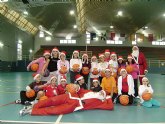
top-left (132, 46), bottom-right (148, 85)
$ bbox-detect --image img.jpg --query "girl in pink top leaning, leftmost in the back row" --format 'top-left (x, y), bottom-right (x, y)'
top-left (27, 50), bottom-right (50, 80)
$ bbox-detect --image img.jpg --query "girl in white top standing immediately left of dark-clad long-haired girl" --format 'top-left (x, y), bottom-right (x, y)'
top-left (70, 50), bottom-right (82, 83)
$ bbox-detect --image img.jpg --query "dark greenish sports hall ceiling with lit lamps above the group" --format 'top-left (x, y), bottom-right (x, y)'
top-left (0, 0), bottom-right (165, 37)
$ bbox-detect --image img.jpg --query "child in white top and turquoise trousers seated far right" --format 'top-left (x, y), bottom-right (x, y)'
top-left (139, 77), bottom-right (160, 108)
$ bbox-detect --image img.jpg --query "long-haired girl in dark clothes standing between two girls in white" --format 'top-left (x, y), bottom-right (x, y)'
top-left (80, 53), bottom-right (91, 85)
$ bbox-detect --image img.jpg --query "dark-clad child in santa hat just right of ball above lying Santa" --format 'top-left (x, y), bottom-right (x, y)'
top-left (75, 74), bottom-right (87, 89)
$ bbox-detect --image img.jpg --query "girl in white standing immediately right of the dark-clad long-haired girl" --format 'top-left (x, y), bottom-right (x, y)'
top-left (90, 56), bottom-right (99, 87)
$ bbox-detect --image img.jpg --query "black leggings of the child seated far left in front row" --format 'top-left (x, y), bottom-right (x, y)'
top-left (20, 91), bottom-right (37, 105)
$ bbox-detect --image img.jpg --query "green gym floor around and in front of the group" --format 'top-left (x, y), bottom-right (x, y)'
top-left (0, 72), bottom-right (165, 124)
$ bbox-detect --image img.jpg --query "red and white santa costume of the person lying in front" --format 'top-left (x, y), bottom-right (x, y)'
top-left (25, 84), bottom-right (114, 115)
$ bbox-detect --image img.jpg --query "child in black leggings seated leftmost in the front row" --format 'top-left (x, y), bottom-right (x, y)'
top-left (15, 74), bottom-right (44, 104)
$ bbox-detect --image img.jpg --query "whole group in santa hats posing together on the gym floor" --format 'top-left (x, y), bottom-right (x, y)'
top-left (16, 46), bottom-right (160, 115)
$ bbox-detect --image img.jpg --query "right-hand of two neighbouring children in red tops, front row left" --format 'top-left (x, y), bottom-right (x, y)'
top-left (57, 75), bottom-right (67, 95)
